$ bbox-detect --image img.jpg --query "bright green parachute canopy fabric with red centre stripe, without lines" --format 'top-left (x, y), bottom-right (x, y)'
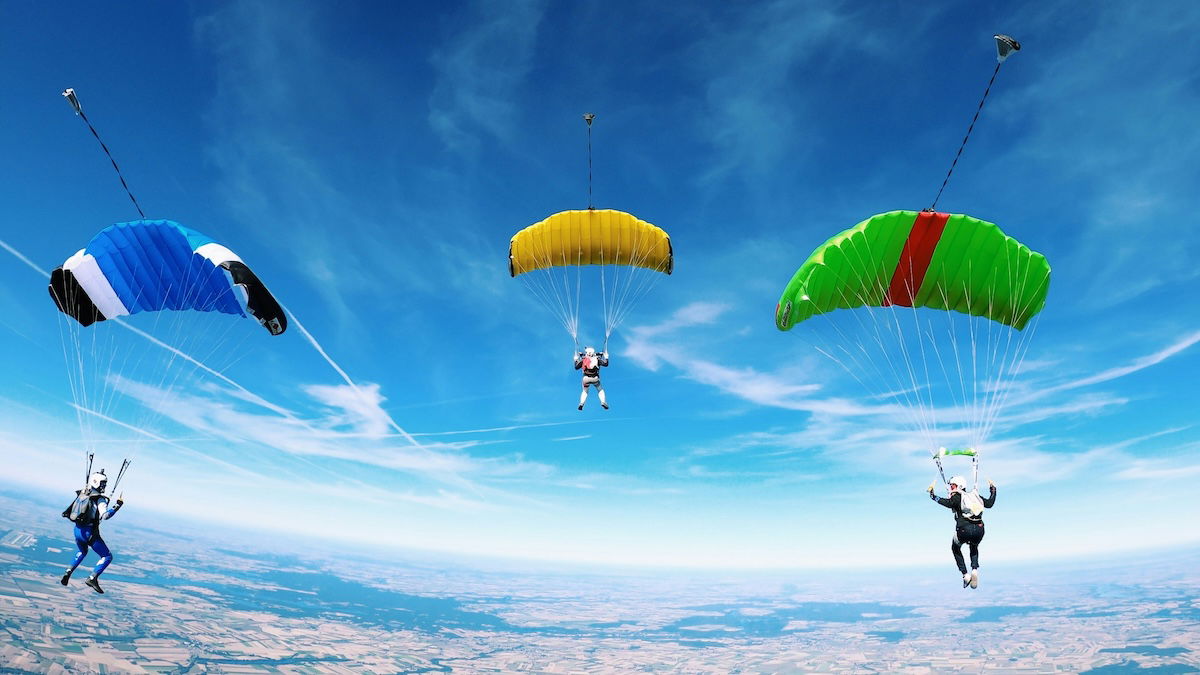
top-left (775, 211), bottom-right (1050, 330)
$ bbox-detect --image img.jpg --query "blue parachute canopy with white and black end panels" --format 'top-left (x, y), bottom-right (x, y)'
top-left (49, 220), bottom-right (287, 335)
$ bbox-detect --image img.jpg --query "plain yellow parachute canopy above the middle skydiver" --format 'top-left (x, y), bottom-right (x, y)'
top-left (509, 209), bottom-right (674, 276)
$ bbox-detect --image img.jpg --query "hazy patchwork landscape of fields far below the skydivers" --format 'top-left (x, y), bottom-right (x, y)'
top-left (0, 487), bottom-right (1200, 673)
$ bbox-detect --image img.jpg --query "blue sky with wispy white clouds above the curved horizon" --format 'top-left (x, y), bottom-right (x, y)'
top-left (0, 1), bottom-right (1200, 567)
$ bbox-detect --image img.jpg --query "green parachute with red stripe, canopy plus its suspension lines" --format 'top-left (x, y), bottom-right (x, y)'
top-left (775, 211), bottom-right (1050, 460)
